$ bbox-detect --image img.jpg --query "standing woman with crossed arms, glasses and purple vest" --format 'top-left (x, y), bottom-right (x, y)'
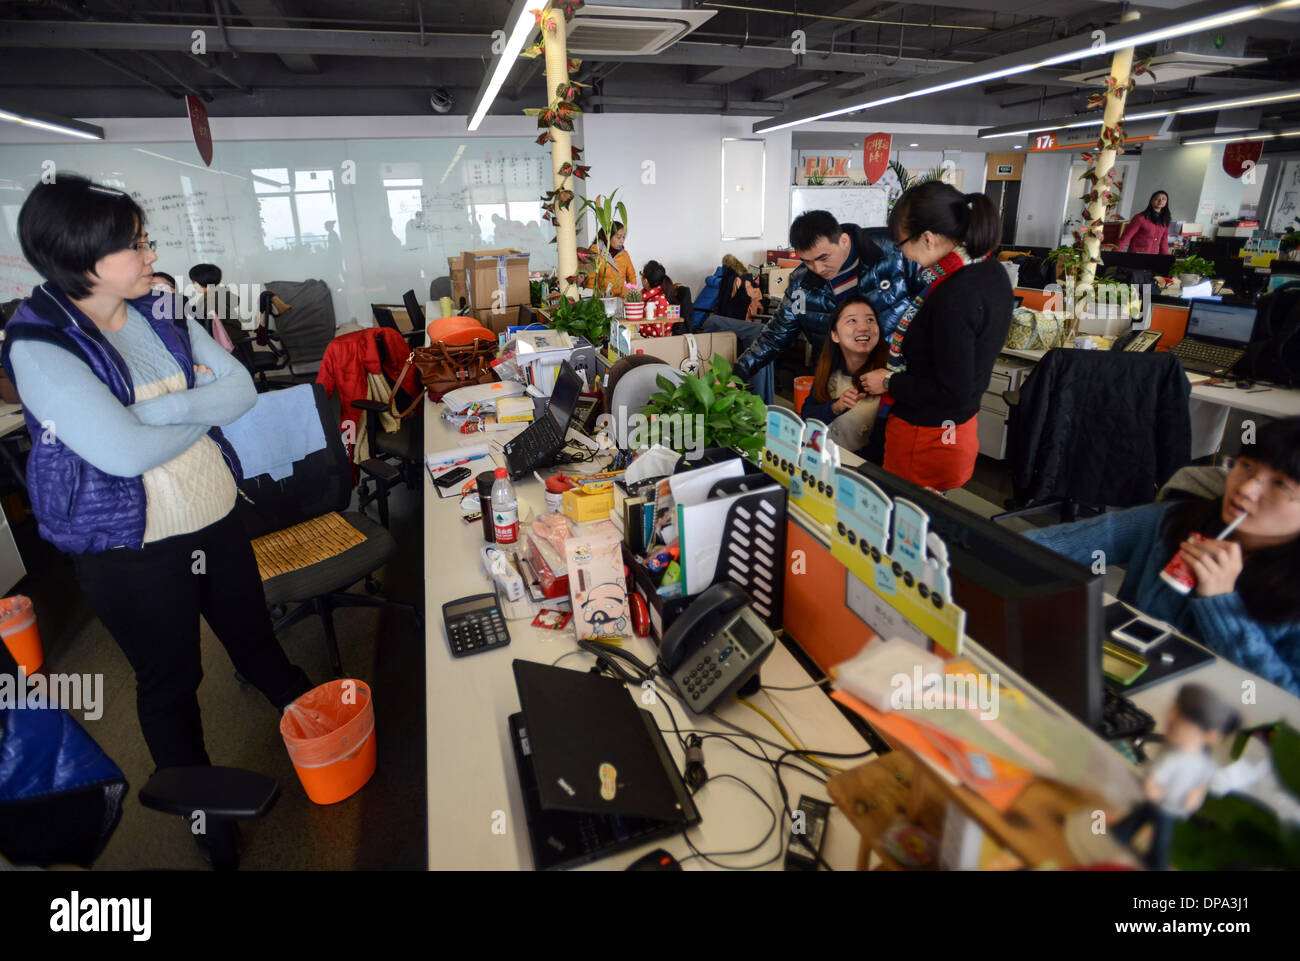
top-left (0, 173), bottom-right (311, 858)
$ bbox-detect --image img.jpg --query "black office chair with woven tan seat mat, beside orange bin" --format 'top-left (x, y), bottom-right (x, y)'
top-left (231, 384), bottom-right (424, 676)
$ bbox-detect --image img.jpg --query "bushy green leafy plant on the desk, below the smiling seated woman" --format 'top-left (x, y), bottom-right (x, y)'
top-left (642, 354), bottom-right (767, 458)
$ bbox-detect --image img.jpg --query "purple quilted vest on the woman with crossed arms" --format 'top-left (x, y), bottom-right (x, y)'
top-left (0, 283), bottom-right (243, 554)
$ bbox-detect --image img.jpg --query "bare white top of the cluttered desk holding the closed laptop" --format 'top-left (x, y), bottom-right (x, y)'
top-left (424, 402), bottom-right (868, 870)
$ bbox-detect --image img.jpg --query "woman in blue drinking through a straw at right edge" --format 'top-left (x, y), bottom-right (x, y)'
top-left (1024, 417), bottom-right (1300, 694)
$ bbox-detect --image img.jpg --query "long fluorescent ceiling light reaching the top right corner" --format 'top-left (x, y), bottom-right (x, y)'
top-left (754, 0), bottom-right (1300, 133)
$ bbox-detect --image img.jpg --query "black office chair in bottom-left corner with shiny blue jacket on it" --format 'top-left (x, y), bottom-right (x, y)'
top-left (0, 645), bottom-right (280, 870)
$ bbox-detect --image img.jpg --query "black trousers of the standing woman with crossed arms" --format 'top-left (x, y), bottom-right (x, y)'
top-left (73, 511), bottom-right (312, 769)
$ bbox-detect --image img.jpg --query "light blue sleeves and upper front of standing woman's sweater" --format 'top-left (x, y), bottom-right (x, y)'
top-left (10, 306), bottom-right (257, 477)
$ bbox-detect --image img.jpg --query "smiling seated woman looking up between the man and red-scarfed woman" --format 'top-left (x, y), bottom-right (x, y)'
top-left (800, 294), bottom-right (889, 464)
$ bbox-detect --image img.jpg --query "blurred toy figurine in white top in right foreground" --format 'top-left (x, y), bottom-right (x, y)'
top-left (1113, 684), bottom-right (1240, 871)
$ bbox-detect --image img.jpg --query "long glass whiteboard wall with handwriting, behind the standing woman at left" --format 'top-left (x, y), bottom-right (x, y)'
top-left (0, 138), bottom-right (555, 324)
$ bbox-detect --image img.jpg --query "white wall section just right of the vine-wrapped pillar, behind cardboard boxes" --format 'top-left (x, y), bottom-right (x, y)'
top-left (581, 113), bottom-right (790, 295)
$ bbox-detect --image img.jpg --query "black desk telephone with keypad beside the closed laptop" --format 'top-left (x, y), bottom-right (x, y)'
top-left (659, 583), bottom-right (776, 714)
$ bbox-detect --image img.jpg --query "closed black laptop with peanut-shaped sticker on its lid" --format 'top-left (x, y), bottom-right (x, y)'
top-left (508, 661), bottom-right (699, 871)
